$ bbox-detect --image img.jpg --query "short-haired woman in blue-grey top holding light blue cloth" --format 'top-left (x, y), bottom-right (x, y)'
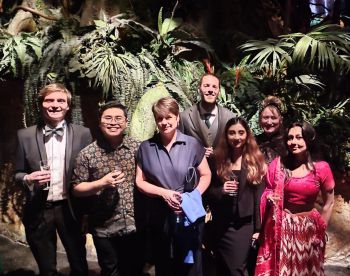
top-left (136, 97), bottom-right (211, 276)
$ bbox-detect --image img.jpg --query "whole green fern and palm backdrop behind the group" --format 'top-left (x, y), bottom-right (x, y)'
top-left (0, 10), bottom-right (350, 168)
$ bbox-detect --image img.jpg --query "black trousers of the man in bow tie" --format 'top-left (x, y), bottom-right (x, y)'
top-left (25, 200), bottom-right (88, 276)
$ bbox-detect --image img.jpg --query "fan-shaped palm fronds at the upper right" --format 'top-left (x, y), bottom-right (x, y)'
top-left (240, 25), bottom-right (350, 77)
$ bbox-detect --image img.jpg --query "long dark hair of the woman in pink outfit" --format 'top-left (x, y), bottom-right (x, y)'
top-left (283, 121), bottom-right (317, 170)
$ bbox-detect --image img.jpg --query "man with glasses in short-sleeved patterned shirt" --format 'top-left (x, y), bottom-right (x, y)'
top-left (72, 102), bottom-right (142, 275)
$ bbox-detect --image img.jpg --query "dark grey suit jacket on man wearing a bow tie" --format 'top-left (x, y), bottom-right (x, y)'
top-left (15, 123), bottom-right (92, 228)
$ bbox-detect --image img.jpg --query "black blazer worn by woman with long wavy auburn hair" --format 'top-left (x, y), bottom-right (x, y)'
top-left (205, 165), bottom-right (264, 232)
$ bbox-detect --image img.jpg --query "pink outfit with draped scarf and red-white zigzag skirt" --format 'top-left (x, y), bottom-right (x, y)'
top-left (255, 157), bottom-right (334, 276)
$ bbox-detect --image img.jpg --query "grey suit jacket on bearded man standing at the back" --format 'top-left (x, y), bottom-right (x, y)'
top-left (179, 104), bottom-right (235, 148)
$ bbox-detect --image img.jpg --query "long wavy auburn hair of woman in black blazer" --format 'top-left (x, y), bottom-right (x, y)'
top-left (214, 117), bottom-right (267, 184)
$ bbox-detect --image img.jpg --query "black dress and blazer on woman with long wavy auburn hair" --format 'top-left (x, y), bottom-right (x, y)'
top-left (208, 167), bottom-right (263, 276)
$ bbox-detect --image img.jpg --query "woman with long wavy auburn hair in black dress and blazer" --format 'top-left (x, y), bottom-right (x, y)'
top-left (208, 117), bottom-right (267, 276)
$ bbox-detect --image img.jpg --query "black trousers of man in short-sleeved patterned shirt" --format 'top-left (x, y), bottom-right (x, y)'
top-left (93, 233), bottom-right (144, 276)
